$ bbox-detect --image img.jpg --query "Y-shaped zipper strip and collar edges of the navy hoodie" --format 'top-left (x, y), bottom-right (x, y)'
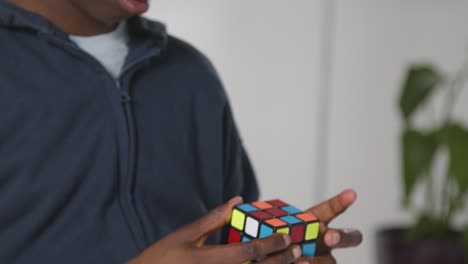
top-left (44, 34), bottom-right (160, 251)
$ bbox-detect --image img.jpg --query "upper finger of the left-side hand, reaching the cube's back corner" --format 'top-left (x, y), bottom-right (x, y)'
top-left (177, 196), bottom-right (242, 242)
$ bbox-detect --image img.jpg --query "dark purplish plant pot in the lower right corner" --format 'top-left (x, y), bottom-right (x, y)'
top-left (377, 228), bottom-right (468, 264)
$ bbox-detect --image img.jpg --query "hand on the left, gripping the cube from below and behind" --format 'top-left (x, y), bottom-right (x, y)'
top-left (127, 197), bottom-right (301, 264)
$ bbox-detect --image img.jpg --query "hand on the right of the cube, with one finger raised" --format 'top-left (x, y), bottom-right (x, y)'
top-left (296, 190), bottom-right (362, 264)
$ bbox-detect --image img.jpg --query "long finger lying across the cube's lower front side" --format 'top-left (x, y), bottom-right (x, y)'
top-left (201, 234), bottom-right (291, 264)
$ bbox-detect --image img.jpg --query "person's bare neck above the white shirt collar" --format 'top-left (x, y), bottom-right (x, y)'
top-left (7, 0), bottom-right (118, 36)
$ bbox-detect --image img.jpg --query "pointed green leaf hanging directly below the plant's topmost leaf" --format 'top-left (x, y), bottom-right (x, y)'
top-left (401, 129), bottom-right (439, 205)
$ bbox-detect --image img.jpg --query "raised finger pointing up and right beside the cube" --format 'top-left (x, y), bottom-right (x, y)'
top-left (307, 190), bottom-right (357, 225)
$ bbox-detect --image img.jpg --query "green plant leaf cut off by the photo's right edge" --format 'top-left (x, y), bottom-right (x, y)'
top-left (445, 124), bottom-right (468, 194)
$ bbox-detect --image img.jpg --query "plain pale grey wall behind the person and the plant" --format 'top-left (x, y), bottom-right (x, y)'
top-left (147, 0), bottom-right (468, 264)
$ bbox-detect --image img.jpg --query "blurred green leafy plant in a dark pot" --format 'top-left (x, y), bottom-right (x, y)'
top-left (377, 62), bottom-right (468, 264)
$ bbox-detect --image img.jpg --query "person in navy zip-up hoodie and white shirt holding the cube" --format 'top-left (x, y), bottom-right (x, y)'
top-left (0, 0), bottom-right (361, 264)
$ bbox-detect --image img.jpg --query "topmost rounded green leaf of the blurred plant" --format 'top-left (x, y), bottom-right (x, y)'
top-left (399, 65), bottom-right (443, 120)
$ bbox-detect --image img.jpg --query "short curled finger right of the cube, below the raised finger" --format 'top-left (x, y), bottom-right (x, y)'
top-left (323, 228), bottom-right (362, 249)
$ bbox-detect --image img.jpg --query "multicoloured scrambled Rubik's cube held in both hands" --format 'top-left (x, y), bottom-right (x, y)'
top-left (228, 200), bottom-right (320, 257)
